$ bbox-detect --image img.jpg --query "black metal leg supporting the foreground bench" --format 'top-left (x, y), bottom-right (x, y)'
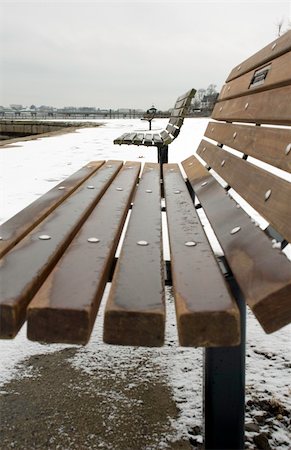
top-left (204, 280), bottom-right (246, 450)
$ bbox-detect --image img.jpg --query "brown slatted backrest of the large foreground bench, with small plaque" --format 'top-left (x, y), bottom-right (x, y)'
top-left (183, 31), bottom-right (291, 332)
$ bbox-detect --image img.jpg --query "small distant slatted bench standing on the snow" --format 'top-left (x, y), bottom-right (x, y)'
top-left (113, 89), bottom-right (196, 164)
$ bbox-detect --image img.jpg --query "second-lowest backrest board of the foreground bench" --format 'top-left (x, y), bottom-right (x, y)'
top-left (197, 140), bottom-right (291, 242)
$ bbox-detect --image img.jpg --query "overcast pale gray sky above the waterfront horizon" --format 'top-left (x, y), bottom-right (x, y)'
top-left (0, 0), bottom-right (291, 109)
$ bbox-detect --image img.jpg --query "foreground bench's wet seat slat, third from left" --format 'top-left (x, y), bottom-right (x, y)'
top-left (27, 162), bottom-right (140, 344)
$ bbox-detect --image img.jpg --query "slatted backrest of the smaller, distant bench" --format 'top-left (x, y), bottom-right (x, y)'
top-left (161, 89), bottom-right (196, 145)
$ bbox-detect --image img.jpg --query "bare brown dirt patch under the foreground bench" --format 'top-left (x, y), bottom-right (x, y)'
top-left (0, 348), bottom-right (193, 450)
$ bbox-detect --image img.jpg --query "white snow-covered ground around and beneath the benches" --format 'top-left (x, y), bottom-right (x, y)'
top-left (0, 119), bottom-right (291, 450)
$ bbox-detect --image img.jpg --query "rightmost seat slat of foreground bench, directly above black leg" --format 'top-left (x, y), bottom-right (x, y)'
top-left (163, 164), bottom-right (240, 347)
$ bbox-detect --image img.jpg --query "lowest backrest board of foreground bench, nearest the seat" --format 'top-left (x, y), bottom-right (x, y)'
top-left (182, 156), bottom-right (291, 333)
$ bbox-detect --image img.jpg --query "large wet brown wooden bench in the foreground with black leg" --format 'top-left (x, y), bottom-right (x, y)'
top-left (0, 31), bottom-right (291, 449)
